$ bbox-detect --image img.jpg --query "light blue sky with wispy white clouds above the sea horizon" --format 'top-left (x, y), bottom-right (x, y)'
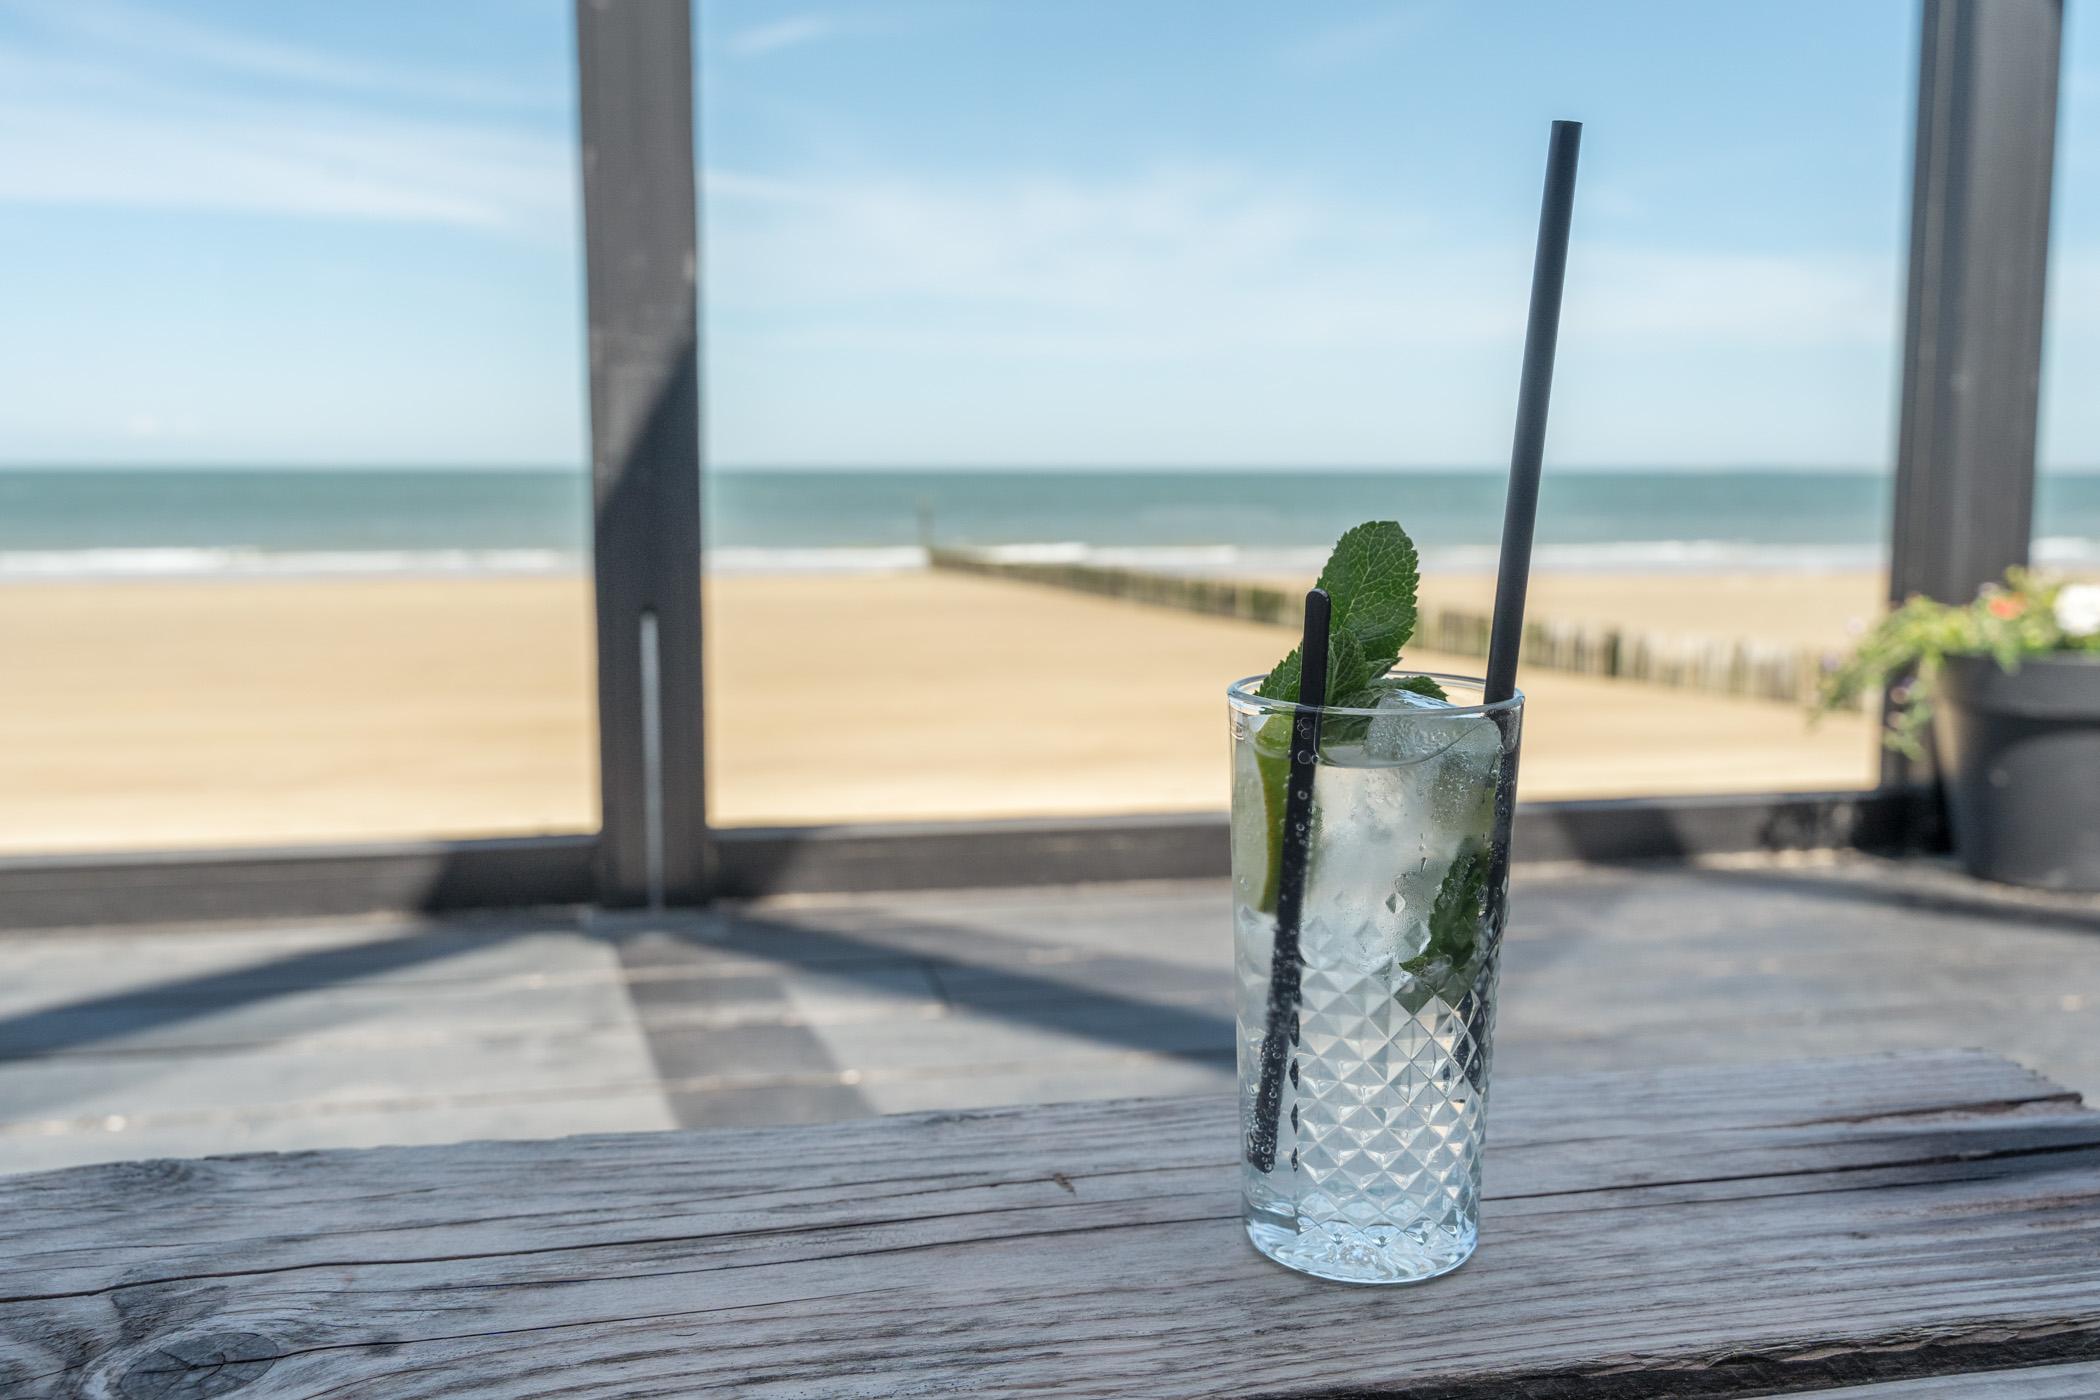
top-left (0, 0), bottom-right (2100, 470)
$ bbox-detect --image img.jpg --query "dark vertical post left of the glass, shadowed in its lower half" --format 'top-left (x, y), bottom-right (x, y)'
top-left (575, 0), bottom-right (708, 907)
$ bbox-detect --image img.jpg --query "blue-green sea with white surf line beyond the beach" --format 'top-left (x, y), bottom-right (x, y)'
top-left (0, 466), bottom-right (2100, 584)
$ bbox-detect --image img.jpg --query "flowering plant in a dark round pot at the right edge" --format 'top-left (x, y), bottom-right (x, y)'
top-left (1821, 569), bottom-right (2100, 890)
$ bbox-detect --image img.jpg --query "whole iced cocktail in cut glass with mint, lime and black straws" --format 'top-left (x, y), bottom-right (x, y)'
top-left (1229, 122), bottom-right (1581, 1282)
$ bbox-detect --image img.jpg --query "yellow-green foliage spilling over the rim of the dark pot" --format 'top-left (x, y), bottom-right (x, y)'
top-left (1817, 569), bottom-right (2100, 758)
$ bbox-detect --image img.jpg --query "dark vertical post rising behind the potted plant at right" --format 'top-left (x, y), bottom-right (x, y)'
top-left (1882, 0), bottom-right (2064, 785)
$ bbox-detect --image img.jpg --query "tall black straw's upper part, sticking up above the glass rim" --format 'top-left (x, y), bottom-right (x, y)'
top-left (1483, 122), bottom-right (1581, 705)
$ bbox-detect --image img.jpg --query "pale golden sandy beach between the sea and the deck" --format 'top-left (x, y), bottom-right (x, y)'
top-left (0, 573), bottom-right (1880, 850)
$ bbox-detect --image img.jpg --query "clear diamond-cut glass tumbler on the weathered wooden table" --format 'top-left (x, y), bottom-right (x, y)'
top-left (1226, 676), bottom-right (1525, 1282)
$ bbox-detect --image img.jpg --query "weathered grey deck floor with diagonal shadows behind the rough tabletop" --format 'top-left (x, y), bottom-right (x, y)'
top-left (0, 861), bottom-right (2100, 1171)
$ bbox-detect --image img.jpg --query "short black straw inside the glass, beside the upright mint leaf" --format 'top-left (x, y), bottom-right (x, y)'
top-left (1247, 588), bottom-right (1334, 1171)
